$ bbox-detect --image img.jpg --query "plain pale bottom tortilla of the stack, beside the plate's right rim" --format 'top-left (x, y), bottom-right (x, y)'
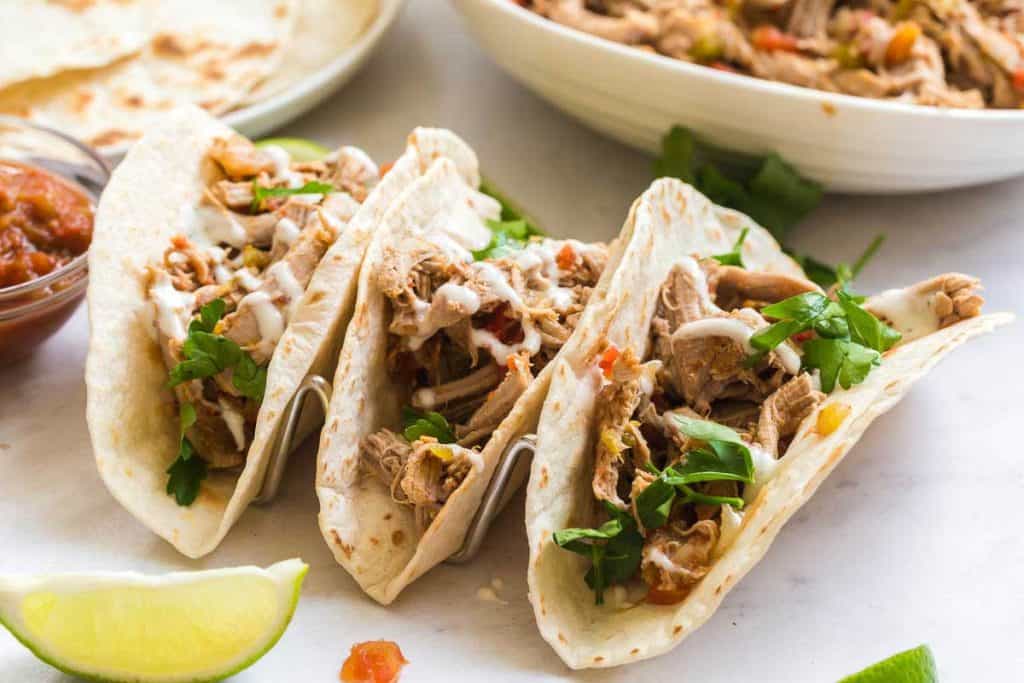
top-left (243, 0), bottom-right (380, 104)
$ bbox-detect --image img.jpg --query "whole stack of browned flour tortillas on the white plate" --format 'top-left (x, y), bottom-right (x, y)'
top-left (0, 0), bottom-right (378, 150)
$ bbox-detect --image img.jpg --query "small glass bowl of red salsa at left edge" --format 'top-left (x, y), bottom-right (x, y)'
top-left (0, 117), bottom-right (111, 367)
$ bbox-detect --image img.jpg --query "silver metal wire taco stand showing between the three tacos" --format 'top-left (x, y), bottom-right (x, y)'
top-left (253, 375), bottom-right (537, 564)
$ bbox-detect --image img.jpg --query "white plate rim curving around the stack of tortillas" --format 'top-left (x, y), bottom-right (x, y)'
top-left (104, 0), bottom-right (406, 159)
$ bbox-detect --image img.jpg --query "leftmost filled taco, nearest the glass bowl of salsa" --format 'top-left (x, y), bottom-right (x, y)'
top-left (86, 108), bottom-right (476, 557)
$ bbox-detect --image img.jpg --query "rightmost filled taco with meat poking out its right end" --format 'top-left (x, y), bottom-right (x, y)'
top-left (526, 179), bottom-right (1011, 669)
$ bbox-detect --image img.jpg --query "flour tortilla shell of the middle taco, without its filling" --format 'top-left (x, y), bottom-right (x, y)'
top-left (316, 154), bottom-right (630, 604)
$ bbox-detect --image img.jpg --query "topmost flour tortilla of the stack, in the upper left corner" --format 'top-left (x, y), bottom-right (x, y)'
top-left (0, 0), bottom-right (148, 88)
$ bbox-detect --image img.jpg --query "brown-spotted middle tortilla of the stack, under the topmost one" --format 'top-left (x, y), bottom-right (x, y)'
top-left (0, 0), bottom-right (298, 148)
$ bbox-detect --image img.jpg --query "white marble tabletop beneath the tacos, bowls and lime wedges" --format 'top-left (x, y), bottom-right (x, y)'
top-left (0, 0), bottom-right (1024, 683)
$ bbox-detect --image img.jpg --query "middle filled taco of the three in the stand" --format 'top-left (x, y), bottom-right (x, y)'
top-left (316, 152), bottom-right (628, 604)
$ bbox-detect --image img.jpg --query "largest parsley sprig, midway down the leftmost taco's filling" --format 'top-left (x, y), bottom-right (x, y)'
top-left (167, 299), bottom-right (266, 400)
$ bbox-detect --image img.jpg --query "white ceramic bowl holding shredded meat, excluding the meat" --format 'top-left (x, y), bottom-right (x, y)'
top-left (452, 0), bottom-right (1024, 194)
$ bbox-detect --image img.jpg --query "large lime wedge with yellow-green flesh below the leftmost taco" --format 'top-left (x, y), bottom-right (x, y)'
top-left (0, 559), bottom-right (309, 683)
